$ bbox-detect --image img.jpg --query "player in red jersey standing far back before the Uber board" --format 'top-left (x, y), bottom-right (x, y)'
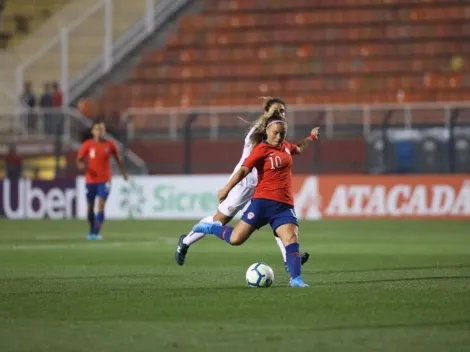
top-left (77, 121), bottom-right (128, 240)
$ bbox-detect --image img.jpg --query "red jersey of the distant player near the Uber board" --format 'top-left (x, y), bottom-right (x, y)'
top-left (78, 139), bottom-right (119, 183)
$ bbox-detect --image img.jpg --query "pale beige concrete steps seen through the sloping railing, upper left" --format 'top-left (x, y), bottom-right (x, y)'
top-left (0, 0), bottom-right (146, 130)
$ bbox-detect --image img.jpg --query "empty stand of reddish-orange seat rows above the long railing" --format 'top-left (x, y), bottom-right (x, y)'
top-left (99, 0), bottom-right (470, 124)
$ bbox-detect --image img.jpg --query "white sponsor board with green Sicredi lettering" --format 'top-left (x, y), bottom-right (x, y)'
top-left (77, 175), bottom-right (230, 220)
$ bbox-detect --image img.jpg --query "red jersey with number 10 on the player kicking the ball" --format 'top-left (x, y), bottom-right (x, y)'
top-left (243, 141), bottom-right (299, 206)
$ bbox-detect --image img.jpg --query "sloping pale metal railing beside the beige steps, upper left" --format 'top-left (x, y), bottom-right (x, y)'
top-left (16, 0), bottom-right (188, 106)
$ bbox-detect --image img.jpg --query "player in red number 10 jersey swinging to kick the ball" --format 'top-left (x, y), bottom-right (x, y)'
top-left (193, 114), bottom-right (319, 287)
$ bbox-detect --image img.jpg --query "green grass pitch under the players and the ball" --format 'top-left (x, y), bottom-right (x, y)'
top-left (0, 220), bottom-right (470, 352)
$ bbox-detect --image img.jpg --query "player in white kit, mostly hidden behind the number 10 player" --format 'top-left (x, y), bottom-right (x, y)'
top-left (175, 98), bottom-right (310, 270)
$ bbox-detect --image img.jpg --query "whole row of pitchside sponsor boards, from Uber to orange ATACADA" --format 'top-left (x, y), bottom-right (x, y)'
top-left (0, 175), bottom-right (470, 220)
